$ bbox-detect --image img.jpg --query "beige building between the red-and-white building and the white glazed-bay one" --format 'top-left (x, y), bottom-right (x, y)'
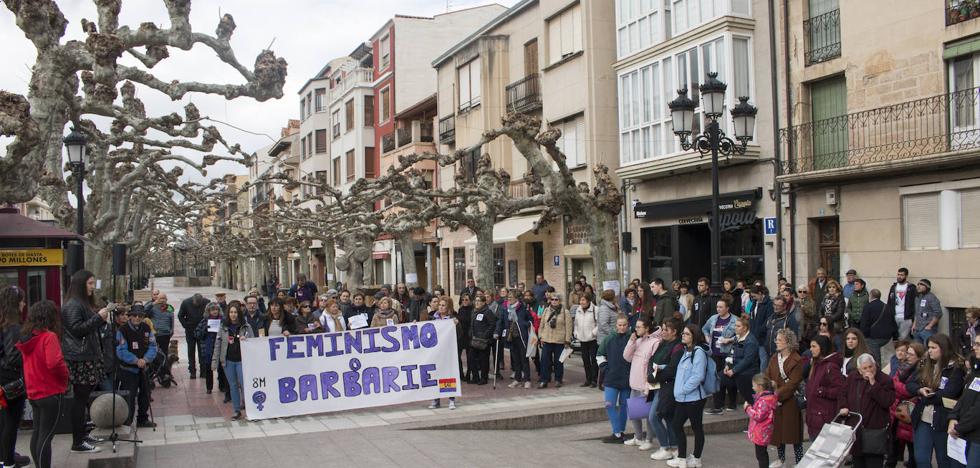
top-left (433, 0), bottom-right (618, 293)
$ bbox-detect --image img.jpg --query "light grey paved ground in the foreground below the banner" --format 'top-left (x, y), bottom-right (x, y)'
top-left (137, 423), bottom-right (764, 468)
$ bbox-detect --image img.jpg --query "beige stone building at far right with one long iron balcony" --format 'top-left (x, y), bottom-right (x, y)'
top-left (778, 0), bottom-right (980, 330)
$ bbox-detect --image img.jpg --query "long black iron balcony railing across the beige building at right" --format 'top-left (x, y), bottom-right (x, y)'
top-left (779, 88), bottom-right (980, 174)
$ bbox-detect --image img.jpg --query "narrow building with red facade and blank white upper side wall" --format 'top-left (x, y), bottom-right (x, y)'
top-left (365, 4), bottom-right (506, 286)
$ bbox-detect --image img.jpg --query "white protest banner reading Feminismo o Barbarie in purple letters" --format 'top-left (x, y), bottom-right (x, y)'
top-left (242, 320), bottom-right (461, 420)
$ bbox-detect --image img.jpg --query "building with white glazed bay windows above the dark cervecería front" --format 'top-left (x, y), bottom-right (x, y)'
top-left (614, 0), bottom-right (778, 284)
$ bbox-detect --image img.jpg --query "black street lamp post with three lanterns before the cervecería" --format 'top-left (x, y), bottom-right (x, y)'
top-left (668, 72), bottom-right (758, 297)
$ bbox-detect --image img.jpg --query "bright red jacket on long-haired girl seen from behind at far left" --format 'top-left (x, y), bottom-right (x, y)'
top-left (17, 331), bottom-right (68, 400)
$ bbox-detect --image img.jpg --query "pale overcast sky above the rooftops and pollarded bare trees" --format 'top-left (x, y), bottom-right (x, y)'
top-left (0, 0), bottom-right (517, 178)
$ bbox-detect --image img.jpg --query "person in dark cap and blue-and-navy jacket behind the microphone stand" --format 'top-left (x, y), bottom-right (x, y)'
top-left (116, 304), bottom-right (158, 427)
